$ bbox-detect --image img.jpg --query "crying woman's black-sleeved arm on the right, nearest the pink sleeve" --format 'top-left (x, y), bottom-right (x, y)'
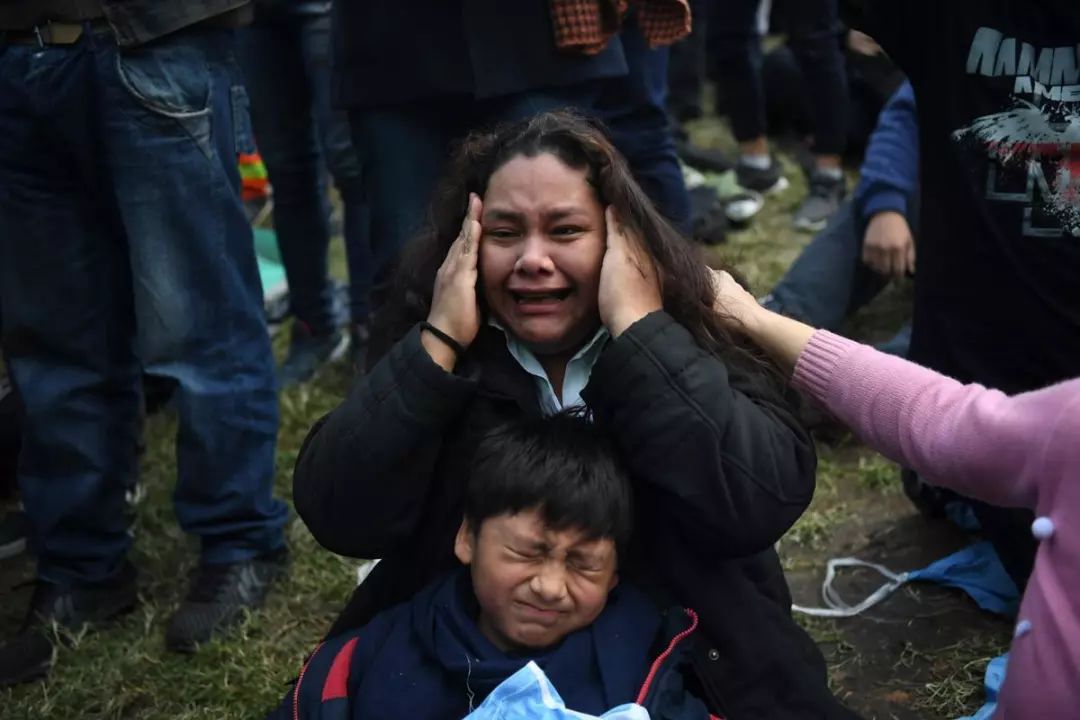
top-left (584, 311), bottom-right (816, 556)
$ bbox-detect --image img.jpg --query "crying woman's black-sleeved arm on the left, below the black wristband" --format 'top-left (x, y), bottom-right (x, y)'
top-left (293, 327), bottom-right (476, 558)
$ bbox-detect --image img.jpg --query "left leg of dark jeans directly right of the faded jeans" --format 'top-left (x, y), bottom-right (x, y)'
top-left (238, 21), bottom-right (337, 335)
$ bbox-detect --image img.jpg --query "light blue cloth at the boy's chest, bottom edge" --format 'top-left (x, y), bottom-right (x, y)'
top-left (465, 661), bottom-right (649, 720)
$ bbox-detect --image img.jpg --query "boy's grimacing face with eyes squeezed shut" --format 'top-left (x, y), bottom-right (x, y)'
top-left (454, 510), bottom-right (619, 652)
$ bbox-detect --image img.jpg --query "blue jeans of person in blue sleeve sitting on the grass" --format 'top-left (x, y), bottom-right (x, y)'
top-left (765, 200), bottom-right (912, 356)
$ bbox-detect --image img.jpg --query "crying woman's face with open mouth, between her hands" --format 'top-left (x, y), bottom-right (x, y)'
top-left (480, 153), bottom-right (606, 355)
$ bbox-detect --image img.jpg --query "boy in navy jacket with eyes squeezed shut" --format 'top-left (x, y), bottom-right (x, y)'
top-left (271, 413), bottom-right (708, 720)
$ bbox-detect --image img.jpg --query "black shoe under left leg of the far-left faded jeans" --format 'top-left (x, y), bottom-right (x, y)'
top-left (0, 563), bottom-right (138, 688)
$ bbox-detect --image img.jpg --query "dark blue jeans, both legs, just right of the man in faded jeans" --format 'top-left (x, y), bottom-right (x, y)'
top-left (240, 14), bottom-right (372, 335)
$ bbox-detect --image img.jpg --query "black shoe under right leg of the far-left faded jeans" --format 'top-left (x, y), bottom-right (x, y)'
top-left (165, 547), bottom-right (288, 652)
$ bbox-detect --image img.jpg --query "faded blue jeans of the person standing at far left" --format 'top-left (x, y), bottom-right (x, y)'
top-left (0, 31), bottom-right (287, 583)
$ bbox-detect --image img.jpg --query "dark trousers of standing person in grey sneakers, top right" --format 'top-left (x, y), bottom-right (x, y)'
top-left (704, 0), bottom-right (848, 154)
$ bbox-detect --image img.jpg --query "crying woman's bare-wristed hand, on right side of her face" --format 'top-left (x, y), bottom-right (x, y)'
top-left (598, 205), bottom-right (663, 338)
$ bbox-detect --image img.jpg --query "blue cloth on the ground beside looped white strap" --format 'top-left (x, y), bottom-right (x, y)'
top-left (907, 541), bottom-right (1020, 617)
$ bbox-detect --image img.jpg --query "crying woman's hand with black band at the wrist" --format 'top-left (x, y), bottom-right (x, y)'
top-left (420, 193), bottom-right (483, 371)
